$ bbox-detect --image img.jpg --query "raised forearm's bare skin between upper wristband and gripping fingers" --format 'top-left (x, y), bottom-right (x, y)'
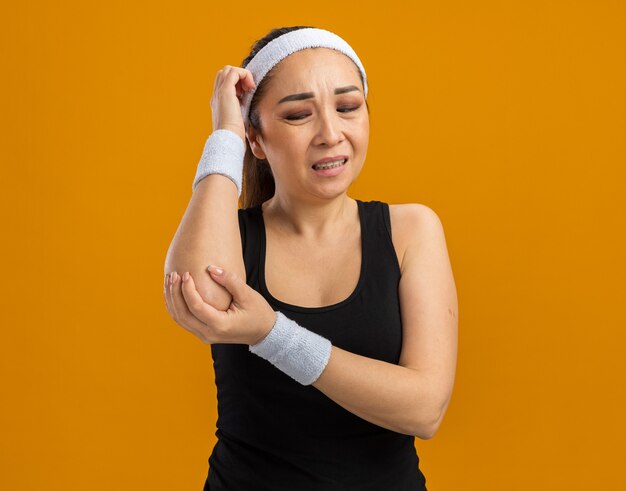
top-left (165, 174), bottom-right (246, 310)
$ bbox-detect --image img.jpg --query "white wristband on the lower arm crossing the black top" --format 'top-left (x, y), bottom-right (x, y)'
top-left (249, 311), bottom-right (332, 385)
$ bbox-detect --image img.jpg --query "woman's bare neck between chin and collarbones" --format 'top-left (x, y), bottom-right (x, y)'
top-left (262, 193), bottom-right (356, 241)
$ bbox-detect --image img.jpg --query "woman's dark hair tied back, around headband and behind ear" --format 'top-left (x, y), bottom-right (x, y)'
top-left (241, 26), bottom-right (369, 208)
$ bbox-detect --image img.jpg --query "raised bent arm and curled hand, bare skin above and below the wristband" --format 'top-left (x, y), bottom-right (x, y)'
top-left (165, 65), bottom-right (254, 310)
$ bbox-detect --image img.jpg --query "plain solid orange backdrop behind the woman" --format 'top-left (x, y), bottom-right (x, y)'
top-left (0, 0), bottom-right (626, 491)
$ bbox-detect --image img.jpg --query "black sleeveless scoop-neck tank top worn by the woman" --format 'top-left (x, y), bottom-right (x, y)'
top-left (204, 200), bottom-right (426, 491)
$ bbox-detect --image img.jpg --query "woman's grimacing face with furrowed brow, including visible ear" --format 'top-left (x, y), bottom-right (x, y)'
top-left (248, 48), bottom-right (369, 203)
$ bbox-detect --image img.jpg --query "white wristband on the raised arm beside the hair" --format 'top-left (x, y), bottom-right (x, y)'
top-left (191, 129), bottom-right (246, 196)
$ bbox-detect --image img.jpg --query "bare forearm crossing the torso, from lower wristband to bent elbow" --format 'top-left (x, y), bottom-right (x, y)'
top-left (313, 346), bottom-right (441, 438)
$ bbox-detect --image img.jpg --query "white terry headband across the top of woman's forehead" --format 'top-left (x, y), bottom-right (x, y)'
top-left (241, 28), bottom-right (367, 124)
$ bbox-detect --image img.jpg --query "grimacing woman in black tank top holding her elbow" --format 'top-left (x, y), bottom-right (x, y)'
top-left (165, 26), bottom-right (457, 491)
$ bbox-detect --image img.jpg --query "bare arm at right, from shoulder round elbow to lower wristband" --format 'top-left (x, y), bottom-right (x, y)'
top-left (313, 204), bottom-right (458, 439)
